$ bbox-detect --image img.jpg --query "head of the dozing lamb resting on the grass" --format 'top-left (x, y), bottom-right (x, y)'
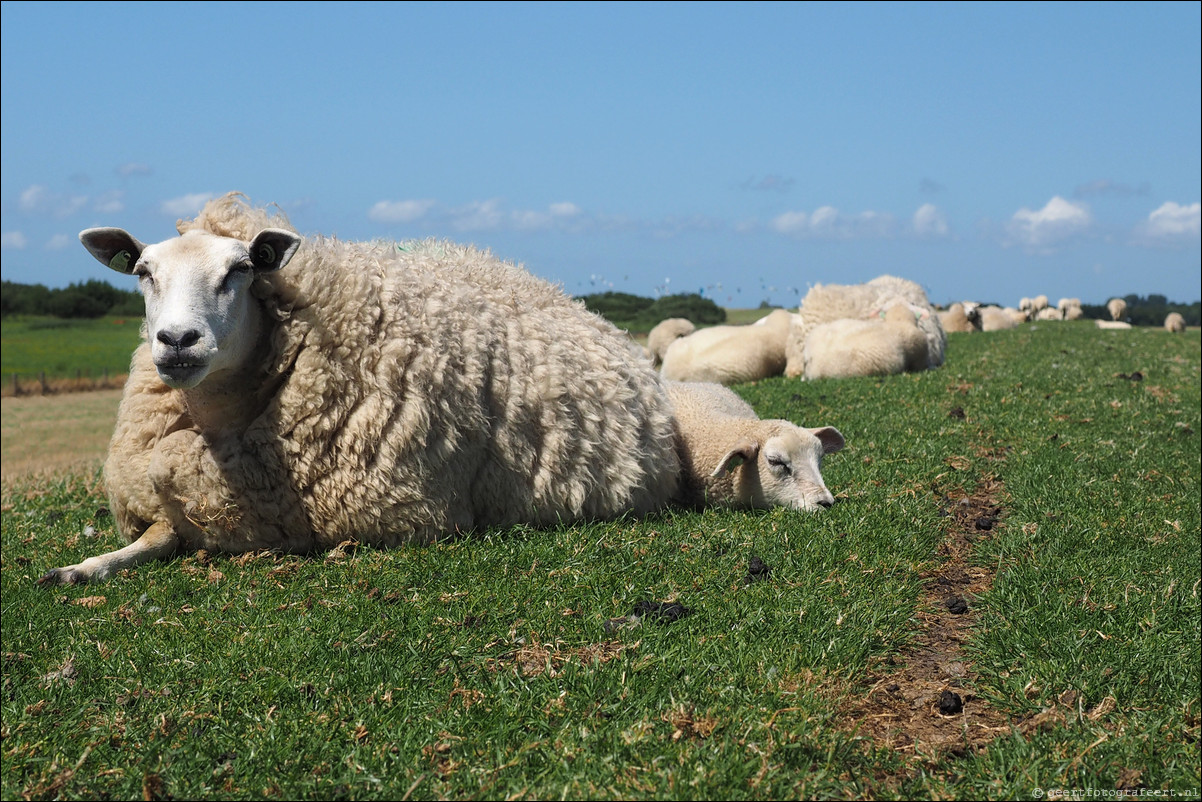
top-left (710, 420), bottom-right (844, 512)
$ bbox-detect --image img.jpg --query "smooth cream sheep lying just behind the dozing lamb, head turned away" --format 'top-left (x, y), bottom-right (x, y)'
top-left (660, 309), bottom-right (792, 385)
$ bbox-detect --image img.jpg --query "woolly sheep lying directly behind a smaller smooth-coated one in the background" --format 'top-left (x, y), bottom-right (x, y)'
top-left (785, 275), bottom-right (947, 376)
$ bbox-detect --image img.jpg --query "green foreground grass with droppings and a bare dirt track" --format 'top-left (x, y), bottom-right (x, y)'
top-left (0, 323), bottom-right (1202, 800)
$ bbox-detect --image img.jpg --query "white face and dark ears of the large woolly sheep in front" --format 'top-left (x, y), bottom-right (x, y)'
top-left (79, 228), bottom-right (301, 390)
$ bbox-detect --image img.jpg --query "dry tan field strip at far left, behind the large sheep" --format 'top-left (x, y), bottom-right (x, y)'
top-left (0, 390), bottom-right (121, 486)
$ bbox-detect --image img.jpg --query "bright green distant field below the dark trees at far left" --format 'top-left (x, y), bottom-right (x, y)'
top-left (0, 316), bottom-right (142, 381)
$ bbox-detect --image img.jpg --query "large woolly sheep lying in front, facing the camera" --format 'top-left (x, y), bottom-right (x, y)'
top-left (41, 194), bottom-right (680, 584)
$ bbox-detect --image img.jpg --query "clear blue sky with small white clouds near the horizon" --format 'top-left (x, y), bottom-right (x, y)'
top-left (0, 2), bottom-right (1202, 307)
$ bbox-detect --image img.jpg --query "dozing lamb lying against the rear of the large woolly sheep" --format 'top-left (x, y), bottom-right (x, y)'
top-left (666, 381), bottom-right (844, 512)
